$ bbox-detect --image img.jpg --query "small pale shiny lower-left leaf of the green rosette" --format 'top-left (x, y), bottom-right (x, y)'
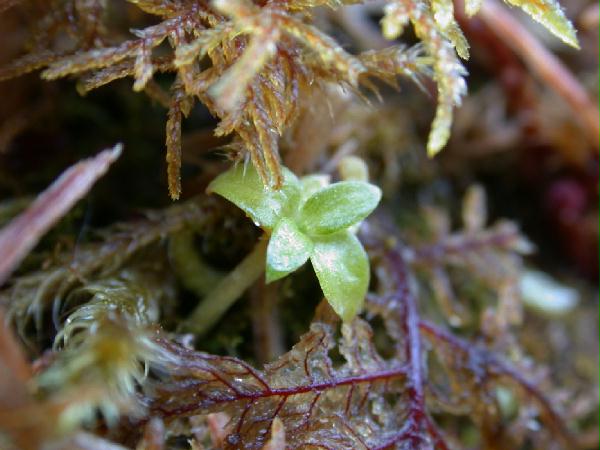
top-left (267, 218), bottom-right (313, 283)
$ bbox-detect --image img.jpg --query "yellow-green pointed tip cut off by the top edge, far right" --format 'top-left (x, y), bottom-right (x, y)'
top-left (505, 0), bottom-right (579, 48)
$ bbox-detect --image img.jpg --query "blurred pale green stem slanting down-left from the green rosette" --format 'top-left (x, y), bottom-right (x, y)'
top-left (183, 239), bottom-right (269, 335)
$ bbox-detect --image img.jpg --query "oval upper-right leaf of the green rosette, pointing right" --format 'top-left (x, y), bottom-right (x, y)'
top-left (298, 181), bottom-right (381, 235)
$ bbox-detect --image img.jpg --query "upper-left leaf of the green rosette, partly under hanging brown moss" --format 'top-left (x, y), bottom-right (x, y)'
top-left (207, 164), bottom-right (300, 230)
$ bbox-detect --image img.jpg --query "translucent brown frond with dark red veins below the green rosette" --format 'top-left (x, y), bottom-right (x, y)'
top-left (146, 303), bottom-right (408, 450)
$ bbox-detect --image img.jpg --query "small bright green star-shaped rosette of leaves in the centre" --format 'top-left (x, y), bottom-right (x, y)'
top-left (208, 164), bottom-right (381, 321)
